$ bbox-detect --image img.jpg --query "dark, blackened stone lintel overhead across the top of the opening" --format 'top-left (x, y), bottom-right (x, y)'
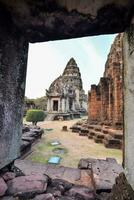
top-left (0, 0), bottom-right (134, 42)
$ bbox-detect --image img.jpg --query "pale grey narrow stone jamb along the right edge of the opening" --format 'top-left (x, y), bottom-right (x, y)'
top-left (123, 24), bottom-right (134, 189)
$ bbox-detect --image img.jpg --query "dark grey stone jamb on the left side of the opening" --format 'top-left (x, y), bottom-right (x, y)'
top-left (0, 8), bottom-right (28, 168)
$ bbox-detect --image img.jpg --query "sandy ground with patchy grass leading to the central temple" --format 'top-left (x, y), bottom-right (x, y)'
top-left (26, 119), bottom-right (122, 167)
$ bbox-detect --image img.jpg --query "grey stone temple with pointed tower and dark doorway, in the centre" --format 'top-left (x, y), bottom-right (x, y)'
top-left (46, 58), bottom-right (87, 119)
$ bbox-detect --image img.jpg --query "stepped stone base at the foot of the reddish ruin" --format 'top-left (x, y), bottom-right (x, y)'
top-left (71, 120), bottom-right (123, 149)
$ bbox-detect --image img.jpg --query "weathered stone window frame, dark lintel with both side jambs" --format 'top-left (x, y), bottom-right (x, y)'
top-left (0, 0), bottom-right (134, 200)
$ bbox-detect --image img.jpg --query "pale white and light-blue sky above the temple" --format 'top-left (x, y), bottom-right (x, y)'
top-left (25, 35), bottom-right (116, 98)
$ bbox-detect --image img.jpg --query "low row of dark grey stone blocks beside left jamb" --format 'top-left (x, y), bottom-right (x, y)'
top-left (20, 125), bottom-right (44, 156)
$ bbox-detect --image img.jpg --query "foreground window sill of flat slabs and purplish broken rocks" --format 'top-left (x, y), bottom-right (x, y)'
top-left (0, 158), bottom-right (123, 200)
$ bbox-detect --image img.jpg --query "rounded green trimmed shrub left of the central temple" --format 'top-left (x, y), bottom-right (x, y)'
top-left (26, 110), bottom-right (45, 125)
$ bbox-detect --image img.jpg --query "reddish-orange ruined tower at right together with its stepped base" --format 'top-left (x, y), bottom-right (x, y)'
top-left (71, 33), bottom-right (123, 149)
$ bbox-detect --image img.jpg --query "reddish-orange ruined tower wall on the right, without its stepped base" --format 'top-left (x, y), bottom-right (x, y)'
top-left (88, 34), bottom-right (123, 126)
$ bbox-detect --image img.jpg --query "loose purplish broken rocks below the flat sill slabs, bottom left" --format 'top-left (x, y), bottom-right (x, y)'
top-left (0, 172), bottom-right (96, 200)
